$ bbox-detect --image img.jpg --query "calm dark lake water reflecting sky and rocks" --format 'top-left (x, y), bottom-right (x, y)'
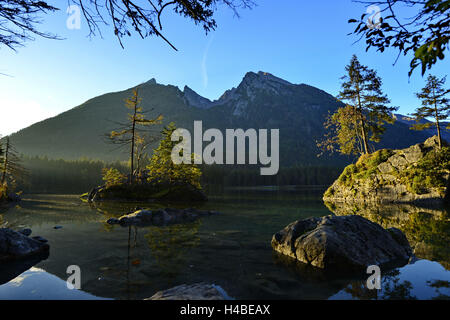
top-left (0, 188), bottom-right (450, 299)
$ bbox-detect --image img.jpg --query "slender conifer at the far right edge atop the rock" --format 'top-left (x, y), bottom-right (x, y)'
top-left (411, 75), bottom-right (450, 149)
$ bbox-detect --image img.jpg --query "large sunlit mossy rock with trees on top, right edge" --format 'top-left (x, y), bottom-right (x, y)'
top-left (323, 137), bottom-right (450, 205)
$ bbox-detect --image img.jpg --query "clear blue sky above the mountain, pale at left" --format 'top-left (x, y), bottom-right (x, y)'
top-left (0, 0), bottom-right (450, 136)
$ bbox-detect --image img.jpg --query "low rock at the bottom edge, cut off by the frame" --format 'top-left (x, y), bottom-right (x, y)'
top-left (146, 283), bottom-right (230, 300)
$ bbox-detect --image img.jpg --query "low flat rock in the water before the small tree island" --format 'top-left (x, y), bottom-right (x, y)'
top-left (107, 208), bottom-right (217, 226)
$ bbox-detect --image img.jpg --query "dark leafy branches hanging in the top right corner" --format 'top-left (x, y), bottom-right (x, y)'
top-left (349, 0), bottom-right (450, 76)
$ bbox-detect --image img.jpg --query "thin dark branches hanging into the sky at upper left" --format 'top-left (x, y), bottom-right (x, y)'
top-left (0, 0), bottom-right (254, 50)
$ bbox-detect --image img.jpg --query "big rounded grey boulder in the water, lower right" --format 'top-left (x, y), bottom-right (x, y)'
top-left (272, 215), bottom-right (412, 272)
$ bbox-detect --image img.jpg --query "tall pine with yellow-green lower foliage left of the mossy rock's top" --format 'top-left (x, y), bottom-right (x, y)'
top-left (318, 55), bottom-right (397, 155)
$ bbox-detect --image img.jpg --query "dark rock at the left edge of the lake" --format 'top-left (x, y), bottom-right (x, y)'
top-left (0, 228), bottom-right (49, 261)
